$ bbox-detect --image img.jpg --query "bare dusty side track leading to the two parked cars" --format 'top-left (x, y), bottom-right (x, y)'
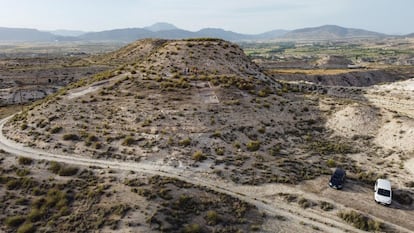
top-left (235, 176), bottom-right (414, 231)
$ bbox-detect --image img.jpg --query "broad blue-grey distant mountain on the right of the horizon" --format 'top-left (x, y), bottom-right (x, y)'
top-left (283, 25), bottom-right (386, 40)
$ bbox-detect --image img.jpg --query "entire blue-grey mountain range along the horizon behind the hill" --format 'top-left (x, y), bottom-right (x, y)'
top-left (0, 23), bottom-right (404, 43)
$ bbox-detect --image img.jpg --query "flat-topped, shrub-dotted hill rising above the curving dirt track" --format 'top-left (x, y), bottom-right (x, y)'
top-left (7, 39), bottom-right (327, 187)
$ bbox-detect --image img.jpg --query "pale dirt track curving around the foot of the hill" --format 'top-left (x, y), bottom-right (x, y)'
top-left (0, 117), bottom-right (410, 232)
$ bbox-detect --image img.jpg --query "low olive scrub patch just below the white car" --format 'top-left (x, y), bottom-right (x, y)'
top-left (338, 210), bottom-right (384, 231)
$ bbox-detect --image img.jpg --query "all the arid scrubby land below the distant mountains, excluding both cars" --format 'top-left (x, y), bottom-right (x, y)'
top-left (0, 38), bottom-right (414, 232)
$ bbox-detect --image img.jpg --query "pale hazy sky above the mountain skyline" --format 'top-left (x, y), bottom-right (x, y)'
top-left (0, 0), bottom-right (414, 34)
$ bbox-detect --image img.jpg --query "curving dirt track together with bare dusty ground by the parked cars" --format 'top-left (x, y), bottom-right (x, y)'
top-left (0, 115), bottom-right (414, 232)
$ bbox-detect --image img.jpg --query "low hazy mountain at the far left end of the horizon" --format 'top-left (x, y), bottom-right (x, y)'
top-left (0, 27), bottom-right (56, 42)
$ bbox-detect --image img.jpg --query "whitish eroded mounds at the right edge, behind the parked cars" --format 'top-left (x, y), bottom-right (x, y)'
top-left (321, 79), bottom-right (414, 184)
